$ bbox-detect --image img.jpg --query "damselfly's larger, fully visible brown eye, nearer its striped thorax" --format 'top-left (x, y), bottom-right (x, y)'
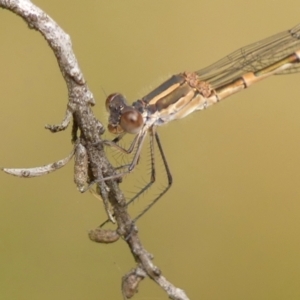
top-left (120, 107), bottom-right (144, 134)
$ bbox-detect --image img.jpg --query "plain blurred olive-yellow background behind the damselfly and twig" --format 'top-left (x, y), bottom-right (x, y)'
top-left (0, 0), bottom-right (300, 300)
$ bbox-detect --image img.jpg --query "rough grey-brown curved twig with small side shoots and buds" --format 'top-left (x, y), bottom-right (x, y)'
top-left (0, 0), bottom-right (188, 300)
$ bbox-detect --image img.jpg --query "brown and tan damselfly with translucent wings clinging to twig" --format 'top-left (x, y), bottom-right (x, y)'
top-left (98, 24), bottom-right (300, 220)
